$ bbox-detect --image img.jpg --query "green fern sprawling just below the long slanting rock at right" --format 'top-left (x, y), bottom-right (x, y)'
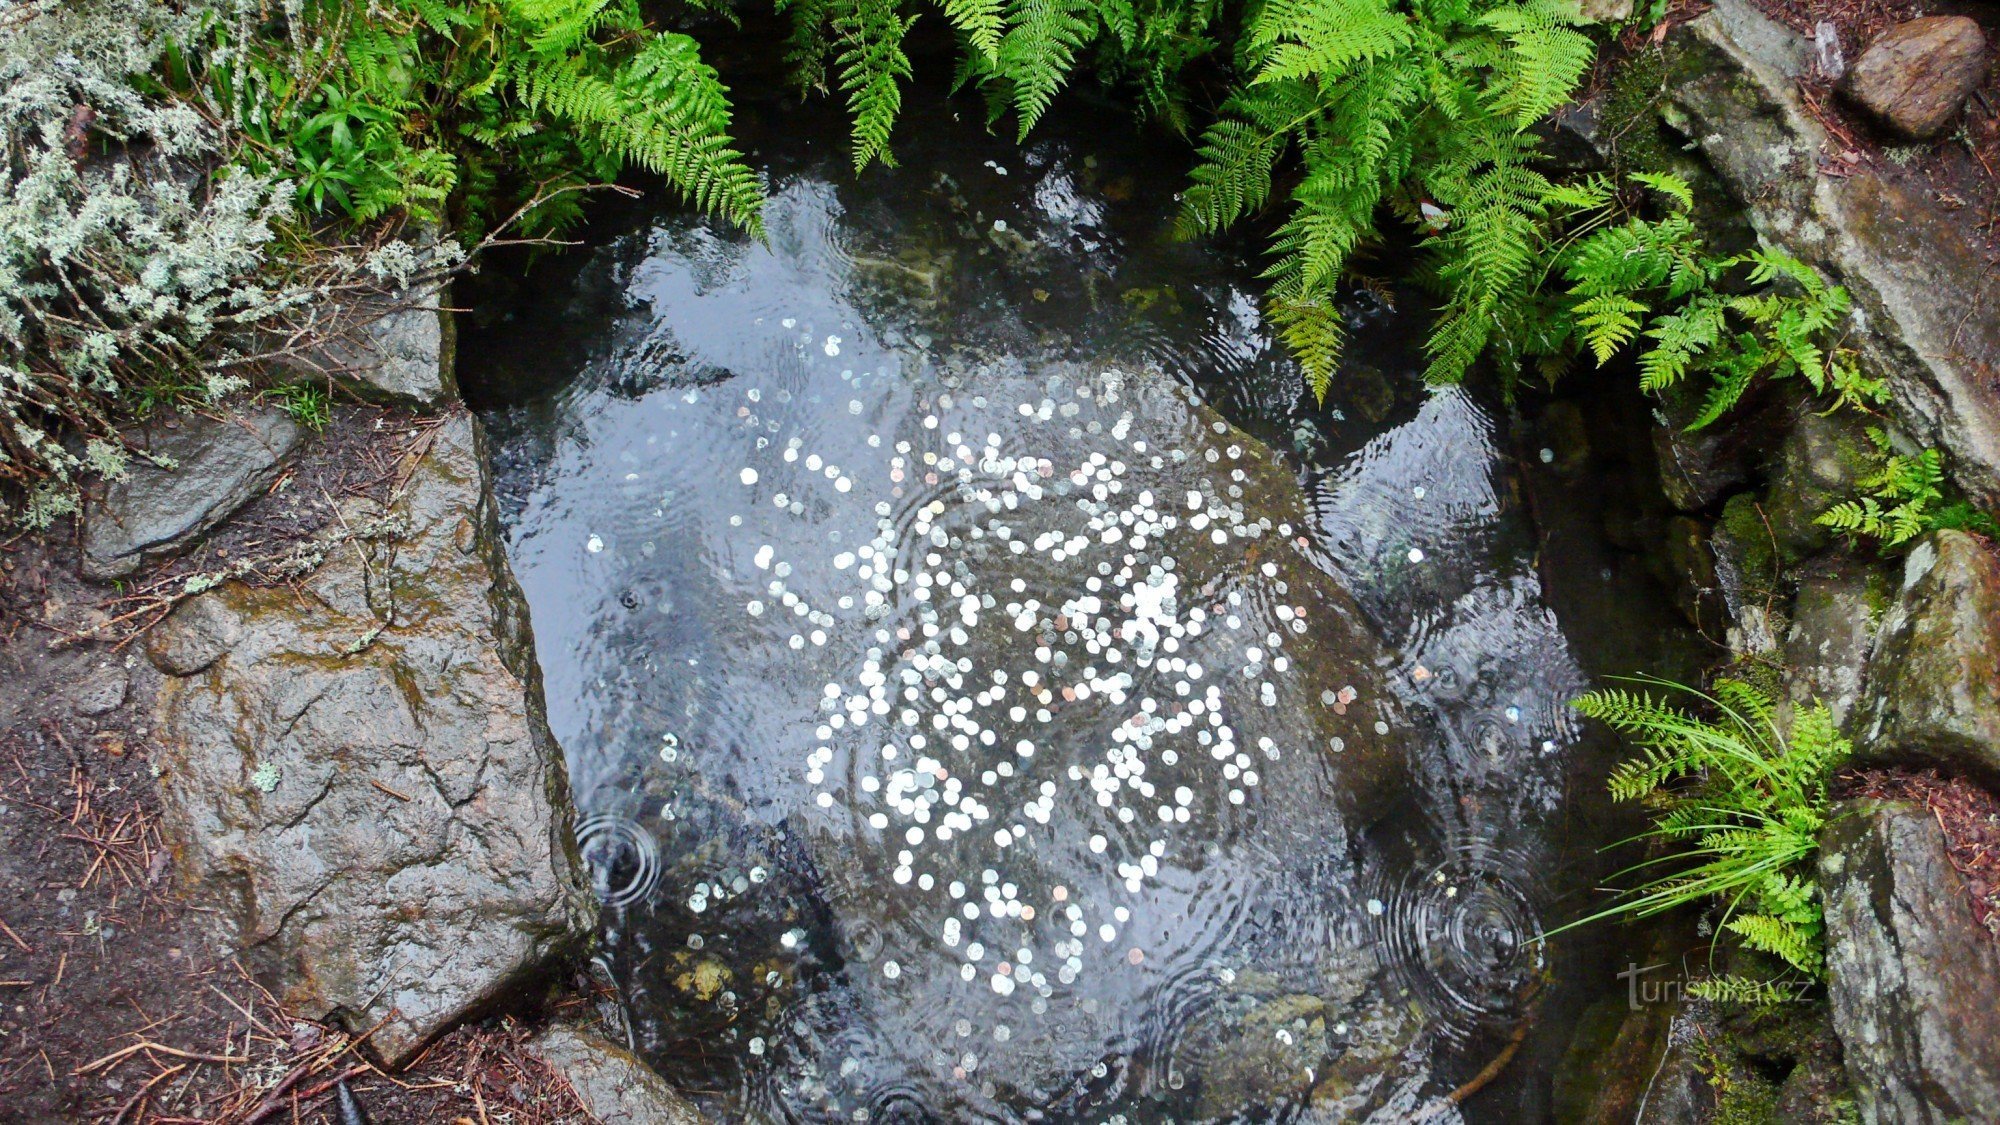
top-left (1534, 172), bottom-right (1888, 430)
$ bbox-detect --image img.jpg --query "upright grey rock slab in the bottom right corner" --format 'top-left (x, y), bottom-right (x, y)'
top-left (1820, 801), bottom-right (2000, 1125)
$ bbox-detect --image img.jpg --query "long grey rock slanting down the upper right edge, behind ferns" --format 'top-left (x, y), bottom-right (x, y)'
top-left (1666, 0), bottom-right (2000, 504)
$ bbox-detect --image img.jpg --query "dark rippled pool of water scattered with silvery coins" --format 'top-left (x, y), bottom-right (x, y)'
top-left (462, 89), bottom-right (1688, 1121)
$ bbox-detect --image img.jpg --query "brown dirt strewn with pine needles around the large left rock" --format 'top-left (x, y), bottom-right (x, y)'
top-left (0, 406), bottom-right (604, 1125)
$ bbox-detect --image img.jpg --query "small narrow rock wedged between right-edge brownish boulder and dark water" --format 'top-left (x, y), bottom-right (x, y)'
top-left (1784, 567), bottom-right (1882, 725)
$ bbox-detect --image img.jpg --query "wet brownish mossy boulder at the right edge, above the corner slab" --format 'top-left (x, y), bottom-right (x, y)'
top-left (1858, 530), bottom-right (2000, 779)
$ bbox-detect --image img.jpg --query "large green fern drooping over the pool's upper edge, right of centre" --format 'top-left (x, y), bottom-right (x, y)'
top-left (1182, 0), bottom-right (1594, 396)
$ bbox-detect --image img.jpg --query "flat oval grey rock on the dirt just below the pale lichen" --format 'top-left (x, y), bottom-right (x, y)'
top-left (82, 406), bottom-right (306, 583)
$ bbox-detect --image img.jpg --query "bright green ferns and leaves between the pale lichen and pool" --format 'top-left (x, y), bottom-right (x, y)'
top-left (176, 0), bottom-right (764, 230)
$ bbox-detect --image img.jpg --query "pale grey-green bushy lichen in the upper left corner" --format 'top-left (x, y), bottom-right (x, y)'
top-left (0, 0), bottom-right (456, 526)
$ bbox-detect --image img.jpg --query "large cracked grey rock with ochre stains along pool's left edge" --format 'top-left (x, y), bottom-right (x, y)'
top-left (150, 412), bottom-right (592, 1061)
